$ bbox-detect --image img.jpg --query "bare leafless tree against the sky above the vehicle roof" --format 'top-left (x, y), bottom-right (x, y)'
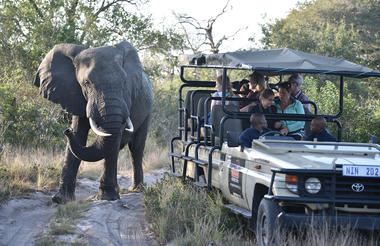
top-left (175, 0), bottom-right (243, 54)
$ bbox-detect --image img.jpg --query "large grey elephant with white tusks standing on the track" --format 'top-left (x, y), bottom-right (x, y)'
top-left (34, 41), bottom-right (153, 203)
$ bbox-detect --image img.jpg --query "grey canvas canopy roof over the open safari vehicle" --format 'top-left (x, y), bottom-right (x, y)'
top-left (181, 48), bottom-right (380, 78)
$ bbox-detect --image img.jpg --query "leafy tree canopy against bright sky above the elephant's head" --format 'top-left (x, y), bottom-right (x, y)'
top-left (0, 0), bottom-right (181, 76)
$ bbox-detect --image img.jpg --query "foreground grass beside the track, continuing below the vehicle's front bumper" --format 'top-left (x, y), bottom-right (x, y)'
top-left (144, 175), bottom-right (380, 246)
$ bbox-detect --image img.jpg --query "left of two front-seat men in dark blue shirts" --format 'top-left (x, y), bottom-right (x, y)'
top-left (239, 113), bottom-right (268, 148)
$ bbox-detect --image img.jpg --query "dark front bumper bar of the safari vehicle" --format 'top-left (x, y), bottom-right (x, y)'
top-left (278, 212), bottom-right (380, 230)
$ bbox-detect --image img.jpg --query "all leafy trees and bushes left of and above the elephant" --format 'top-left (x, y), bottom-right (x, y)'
top-left (0, 0), bottom-right (186, 147)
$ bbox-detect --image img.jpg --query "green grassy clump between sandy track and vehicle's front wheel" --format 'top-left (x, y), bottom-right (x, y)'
top-left (144, 175), bottom-right (251, 245)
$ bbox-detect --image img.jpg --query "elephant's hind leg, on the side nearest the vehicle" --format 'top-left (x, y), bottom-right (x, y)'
top-left (128, 117), bottom-right (149, 191)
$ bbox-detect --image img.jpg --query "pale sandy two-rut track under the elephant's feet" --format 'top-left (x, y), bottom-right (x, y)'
top-left (0, 170), bottom-right (163, 246)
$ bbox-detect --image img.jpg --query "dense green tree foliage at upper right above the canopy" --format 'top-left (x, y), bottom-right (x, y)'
top-left (261, 0), bottom-right (380, 69)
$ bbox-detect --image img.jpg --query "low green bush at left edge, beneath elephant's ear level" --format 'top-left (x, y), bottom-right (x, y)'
top-left (0, 69), bottom-right (67, 148)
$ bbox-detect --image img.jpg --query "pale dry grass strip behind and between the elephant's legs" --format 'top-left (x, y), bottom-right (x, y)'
top-left (0, 136), bottom-right (169, 205)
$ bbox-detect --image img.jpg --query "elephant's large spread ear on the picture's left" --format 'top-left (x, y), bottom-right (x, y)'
top-left (34, 44), bottom-right (87, 116)
